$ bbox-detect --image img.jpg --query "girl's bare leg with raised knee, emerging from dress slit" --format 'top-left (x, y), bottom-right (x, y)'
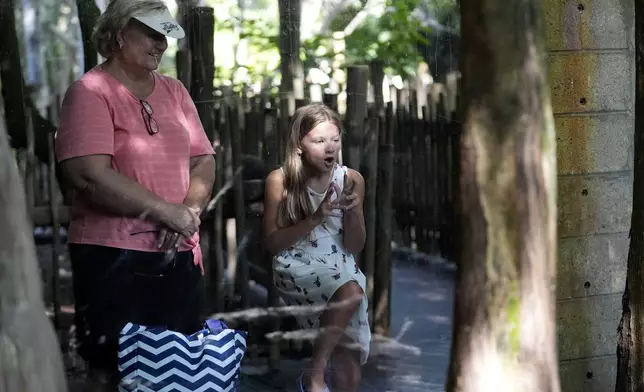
top-left (305, 281), bottom-right (364, 392)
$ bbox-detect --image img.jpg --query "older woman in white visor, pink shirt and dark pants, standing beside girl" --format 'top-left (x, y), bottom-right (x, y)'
top-left (56, 0), bottom-right (215, 388)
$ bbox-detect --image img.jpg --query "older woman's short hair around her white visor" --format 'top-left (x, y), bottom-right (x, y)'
top-left (92, 0), bottom-right (167, 58)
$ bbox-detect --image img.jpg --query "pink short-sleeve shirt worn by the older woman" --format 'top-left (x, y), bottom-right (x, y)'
top-left (56, 66), bottom-right (214, 251)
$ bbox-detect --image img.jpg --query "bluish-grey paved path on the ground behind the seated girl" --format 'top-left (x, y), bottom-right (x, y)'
top-left (239, 254), bottom-right (454, 392)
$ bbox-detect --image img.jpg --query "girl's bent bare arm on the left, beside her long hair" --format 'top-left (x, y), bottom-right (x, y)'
top-left (264, 169), bottom-right (321, 255)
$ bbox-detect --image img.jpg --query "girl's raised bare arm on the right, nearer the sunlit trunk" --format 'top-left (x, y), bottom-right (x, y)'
top-left (343, 169), bottom-right (366, 254)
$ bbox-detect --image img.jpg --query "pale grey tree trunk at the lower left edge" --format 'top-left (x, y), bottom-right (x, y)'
top-left (0, 82), bottom-right (67, 392)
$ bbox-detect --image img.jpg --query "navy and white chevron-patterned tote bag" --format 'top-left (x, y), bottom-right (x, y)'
top-left (118, 319), bottom-right (247, 392)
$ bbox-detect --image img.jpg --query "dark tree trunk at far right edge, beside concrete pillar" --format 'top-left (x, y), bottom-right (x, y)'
top-left (615, 1), bottom-right (644, 392)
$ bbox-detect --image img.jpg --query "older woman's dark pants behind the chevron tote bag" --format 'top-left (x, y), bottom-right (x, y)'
top-left (69, 244), bottom-right (203, 382)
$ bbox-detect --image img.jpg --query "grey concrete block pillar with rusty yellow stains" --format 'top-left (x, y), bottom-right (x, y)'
top-left (543, 0), bottom-right (635, 392)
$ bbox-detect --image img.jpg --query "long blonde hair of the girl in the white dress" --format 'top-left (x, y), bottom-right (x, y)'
top-left (278, 103), bottom-right (342, 227)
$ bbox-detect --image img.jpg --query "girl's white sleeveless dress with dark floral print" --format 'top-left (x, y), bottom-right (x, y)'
top-left (273, 165), bottom-right (371, 365)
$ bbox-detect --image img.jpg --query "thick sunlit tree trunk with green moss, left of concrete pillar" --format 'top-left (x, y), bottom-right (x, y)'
top-left (447, 0), bottom-right (560, 392)
